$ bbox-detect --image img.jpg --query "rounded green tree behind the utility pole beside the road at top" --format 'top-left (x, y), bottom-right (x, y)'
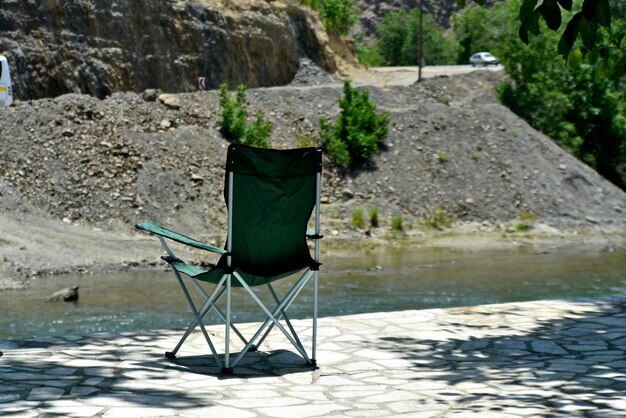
top-left (374, 9), bottom-right (456, 65)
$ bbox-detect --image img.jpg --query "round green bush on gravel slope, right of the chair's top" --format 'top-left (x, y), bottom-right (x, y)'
top-left (320, 81), bottom-right (389, 167)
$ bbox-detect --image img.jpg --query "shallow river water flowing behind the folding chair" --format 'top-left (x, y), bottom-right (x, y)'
top-left (0, 248), bottom-right (626, 342)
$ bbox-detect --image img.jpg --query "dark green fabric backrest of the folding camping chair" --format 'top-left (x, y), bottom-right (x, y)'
top-left (224, 144), bottom-right (322, 277)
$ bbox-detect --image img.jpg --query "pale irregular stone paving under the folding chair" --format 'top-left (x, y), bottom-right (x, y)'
top-left (0, 297), bottom-right (626, 418)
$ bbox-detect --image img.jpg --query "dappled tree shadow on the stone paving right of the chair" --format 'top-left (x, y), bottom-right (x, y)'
top-left (366, 298), bottom-right (626, 417)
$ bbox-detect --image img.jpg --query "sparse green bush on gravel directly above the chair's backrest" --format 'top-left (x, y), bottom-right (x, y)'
top-left (220, 83), bottom-right (273, 148)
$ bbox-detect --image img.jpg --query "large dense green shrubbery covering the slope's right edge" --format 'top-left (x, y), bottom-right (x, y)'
top-left (496, 0), bottom-right (626, 188)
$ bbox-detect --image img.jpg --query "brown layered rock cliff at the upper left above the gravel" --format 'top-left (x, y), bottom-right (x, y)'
top-left (0, 0), bottom-right (336, 100)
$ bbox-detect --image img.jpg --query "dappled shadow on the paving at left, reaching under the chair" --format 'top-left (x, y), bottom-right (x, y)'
top-left (0, 332), bottom-right (314, 415)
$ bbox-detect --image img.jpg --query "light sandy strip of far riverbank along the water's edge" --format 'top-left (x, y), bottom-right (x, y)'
top-left (0, 208), bottom-right (626, 291)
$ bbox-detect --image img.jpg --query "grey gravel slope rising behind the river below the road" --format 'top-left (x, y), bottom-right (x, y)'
top-left (0, 62), bottom-right (626, 289)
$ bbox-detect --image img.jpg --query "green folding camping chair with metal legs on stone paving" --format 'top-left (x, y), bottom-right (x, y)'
top-left (135, 144), bottom-right (322, 374)
